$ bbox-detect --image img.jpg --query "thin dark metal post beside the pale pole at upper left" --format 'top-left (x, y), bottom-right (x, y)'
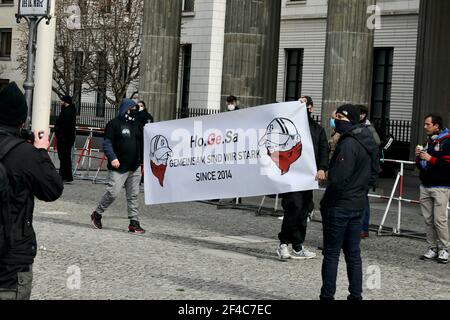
top-left (23, 17), bottom-right (38, 129)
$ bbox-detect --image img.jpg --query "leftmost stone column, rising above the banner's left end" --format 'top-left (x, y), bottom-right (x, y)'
top-left (139, 0), bottom-right (182, 121)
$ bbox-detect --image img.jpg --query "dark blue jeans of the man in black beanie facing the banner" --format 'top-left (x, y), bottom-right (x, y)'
top-left (320, 208), bottom-right (363, 300)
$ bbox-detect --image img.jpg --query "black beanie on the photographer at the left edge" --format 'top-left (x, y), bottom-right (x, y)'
top-left (0, 82), bottom-right (28, 127)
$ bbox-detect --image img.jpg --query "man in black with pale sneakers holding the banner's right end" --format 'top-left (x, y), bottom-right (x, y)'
top-left (277, 96), bottom-right (329, 260)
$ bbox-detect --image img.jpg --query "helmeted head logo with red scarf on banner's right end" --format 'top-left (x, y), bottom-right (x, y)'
top-left (259, 118), bottom-right (302, 175)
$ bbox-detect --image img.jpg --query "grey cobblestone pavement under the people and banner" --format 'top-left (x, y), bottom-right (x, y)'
top-left (32, 180), bottom-right (450, 300)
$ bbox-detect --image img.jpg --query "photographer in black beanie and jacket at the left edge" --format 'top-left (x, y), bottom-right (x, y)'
top-left (0, 83), bottom-right (64, 300)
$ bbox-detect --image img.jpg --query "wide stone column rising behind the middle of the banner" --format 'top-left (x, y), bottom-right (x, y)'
top-left (221, 0), bottom-right (281, 110)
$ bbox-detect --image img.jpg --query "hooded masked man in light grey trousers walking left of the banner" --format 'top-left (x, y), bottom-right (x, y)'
top-left (91, 99), bottom-right (145, 234)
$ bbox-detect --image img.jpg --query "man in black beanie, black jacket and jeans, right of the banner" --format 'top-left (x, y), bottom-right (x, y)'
top-left (320, 104), bottom-right (379, 300)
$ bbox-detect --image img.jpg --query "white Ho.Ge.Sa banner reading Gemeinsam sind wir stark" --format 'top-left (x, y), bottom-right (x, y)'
top-left (144, 102), bottom-right (318, 205)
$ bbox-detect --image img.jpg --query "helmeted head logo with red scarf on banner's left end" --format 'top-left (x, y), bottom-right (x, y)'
top-left (150, 135), bottom-right (173, 187)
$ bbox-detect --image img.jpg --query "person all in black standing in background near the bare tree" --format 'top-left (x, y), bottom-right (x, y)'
top-left (55, 96), bottom-right (77, 182)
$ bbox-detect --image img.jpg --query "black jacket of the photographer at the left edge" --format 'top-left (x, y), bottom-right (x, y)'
top-left (0, 132), bottom-right (64, 288)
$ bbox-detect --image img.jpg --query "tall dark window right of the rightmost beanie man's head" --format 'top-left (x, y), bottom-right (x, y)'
top-left (371, 48), bottom-right (394, 120)
